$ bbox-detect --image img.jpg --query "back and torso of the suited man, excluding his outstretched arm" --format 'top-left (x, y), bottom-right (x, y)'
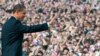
top-left (2, 17), bottom-right (23, 56)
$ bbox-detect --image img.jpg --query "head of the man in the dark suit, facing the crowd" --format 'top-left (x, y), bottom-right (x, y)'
top-left (13, 4), bottom-right (26, 20)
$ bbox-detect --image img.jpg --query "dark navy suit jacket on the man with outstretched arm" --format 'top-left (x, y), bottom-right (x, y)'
top-left (1, 16), bottom-right (48, 56)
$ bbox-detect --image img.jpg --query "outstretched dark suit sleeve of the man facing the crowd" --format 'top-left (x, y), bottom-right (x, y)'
top-left (17, 23), bottom-right (49, 33)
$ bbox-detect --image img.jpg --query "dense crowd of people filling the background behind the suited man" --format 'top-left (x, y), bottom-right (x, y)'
top-left (0, 0), bottom-right (100, 56)
